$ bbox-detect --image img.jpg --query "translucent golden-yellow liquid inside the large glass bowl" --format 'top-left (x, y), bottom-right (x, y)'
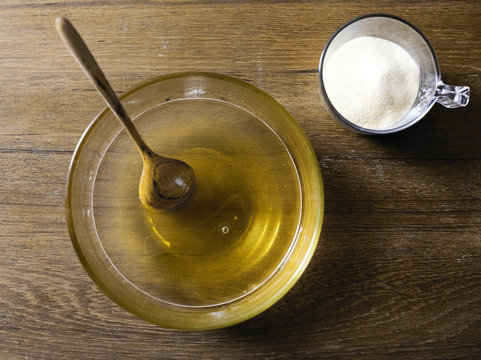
top-left (93, 99), bottom-right (301, 306)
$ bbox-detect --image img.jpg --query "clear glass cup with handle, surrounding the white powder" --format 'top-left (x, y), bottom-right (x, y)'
top-left (319, 14), bottom-right (470, 134)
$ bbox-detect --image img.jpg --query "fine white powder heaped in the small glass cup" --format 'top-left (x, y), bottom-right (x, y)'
top-left (323, 36), bottom-right (419, 130)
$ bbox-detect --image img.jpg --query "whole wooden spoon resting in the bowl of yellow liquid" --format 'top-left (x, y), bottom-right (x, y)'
top-left (55, 17), bottom-right (195, 211)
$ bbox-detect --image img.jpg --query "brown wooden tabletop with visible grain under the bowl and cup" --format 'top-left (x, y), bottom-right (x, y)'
top-left (0, 0), bottom-right (481, 359)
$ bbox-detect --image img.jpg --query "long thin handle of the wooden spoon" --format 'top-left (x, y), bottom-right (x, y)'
top-left (55, 17), bottom-right (151, 155)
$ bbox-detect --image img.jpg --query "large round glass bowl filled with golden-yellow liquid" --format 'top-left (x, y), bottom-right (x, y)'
top-left (66, 72), bottom-right (324, 330)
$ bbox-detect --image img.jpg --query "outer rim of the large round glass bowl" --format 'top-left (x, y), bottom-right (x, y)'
top-left (65, 71), bottom-right (324, 330)
